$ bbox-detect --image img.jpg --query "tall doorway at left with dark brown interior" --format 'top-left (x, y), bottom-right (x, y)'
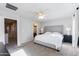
top-left (4, 18), bottom-right (17, 45)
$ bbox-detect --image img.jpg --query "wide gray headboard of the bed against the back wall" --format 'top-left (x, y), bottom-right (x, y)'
top-left (44, 25), bottom-right (63, 34)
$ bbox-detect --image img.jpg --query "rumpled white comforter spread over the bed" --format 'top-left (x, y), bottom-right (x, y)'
top-left (35, 32), bottom-right (63, 49)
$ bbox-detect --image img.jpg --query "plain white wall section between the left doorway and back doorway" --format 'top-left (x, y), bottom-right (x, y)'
top-left (19, 19), bottom-right (33, 44)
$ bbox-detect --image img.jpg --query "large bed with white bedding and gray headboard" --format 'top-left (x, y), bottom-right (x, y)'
top-left (34, 26), bottom-right (63, 50)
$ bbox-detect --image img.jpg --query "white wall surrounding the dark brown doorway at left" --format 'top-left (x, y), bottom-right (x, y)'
top-left (0, 10), bottom-right (32, 46)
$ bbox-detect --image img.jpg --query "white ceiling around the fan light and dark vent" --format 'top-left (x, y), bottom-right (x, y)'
top-left (0, 3), bottom-right (79, 20)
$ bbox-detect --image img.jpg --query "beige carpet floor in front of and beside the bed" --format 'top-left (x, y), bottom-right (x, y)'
top-left (8, 42), bottom-right (79, 56)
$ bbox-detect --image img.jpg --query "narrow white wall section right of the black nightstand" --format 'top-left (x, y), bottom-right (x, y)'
top-left (72, 12), bottom-right (78, 47)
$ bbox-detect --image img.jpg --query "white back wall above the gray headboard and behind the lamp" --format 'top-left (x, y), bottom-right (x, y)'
top-left (42, 17), bottom-right (72, 34)
